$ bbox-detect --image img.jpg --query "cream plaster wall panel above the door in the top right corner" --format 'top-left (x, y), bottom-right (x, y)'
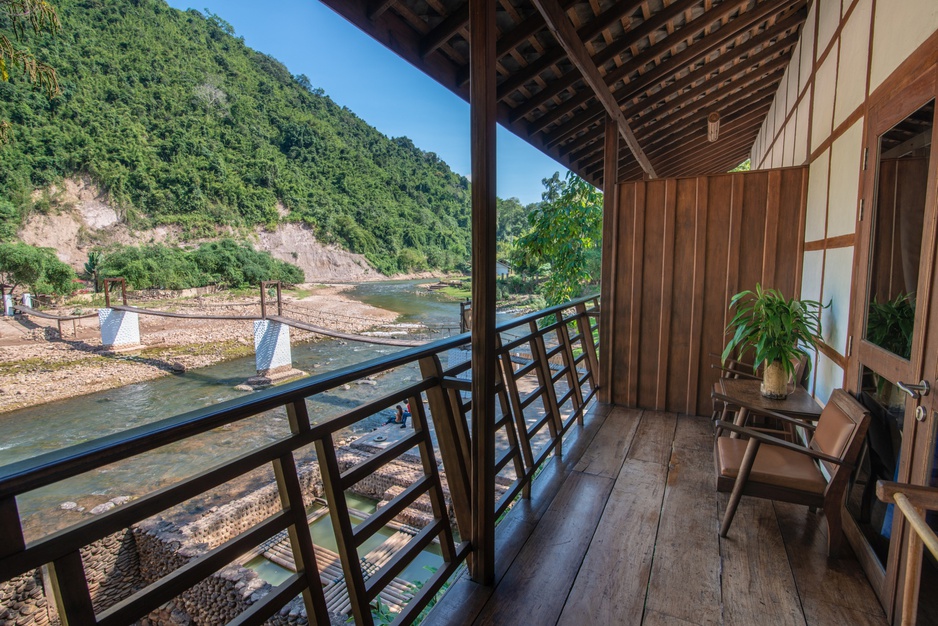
top-left (870, 0), bottom-right (938, 92)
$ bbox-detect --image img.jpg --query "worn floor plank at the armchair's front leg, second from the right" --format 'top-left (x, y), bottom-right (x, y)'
top-left (711, 492), bottom-right (805, 626)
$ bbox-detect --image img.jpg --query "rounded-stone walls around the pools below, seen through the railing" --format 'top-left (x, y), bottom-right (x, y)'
top-left (0, 447), bottom-right (445, 626)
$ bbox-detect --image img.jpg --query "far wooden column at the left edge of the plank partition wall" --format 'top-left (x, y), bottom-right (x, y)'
top-left (600, 115), bottom-right (619, 403)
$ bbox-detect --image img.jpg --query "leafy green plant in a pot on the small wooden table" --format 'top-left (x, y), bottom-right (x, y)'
top-left (723, 284), bottom-right (823, 399)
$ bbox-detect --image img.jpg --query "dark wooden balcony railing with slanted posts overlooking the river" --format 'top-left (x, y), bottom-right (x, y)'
top-left (0, 298), bottom-right (598, 625)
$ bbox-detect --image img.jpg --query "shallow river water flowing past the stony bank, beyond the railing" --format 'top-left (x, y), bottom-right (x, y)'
top-left (0, 281), bottom-right (490, 538)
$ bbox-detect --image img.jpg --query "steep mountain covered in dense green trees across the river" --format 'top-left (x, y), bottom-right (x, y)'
top-left (0, 0), bottom-right (470, 273)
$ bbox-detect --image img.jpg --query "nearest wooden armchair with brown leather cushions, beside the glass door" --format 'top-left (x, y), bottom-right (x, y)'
top-left (714, 389), bottom-right (870, 556)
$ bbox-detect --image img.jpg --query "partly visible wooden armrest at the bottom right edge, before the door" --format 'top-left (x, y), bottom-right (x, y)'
top-left (876, 480), bottom-right (938, 626)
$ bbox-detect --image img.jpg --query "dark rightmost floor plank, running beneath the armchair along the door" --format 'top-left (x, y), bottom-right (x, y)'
top-left (774, 502), bottom-right (886, 624)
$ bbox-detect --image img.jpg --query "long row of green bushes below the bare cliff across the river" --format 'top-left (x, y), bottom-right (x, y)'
top-left (98, 239), bottom-right (304, 289)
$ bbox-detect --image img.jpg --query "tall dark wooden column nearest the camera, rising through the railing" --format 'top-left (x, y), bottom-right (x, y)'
top-left (469, 0), bottom-right (497, 585)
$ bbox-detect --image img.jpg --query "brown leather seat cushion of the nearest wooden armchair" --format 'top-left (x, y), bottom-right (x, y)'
top-left (717, 437), bottom-right (827, 494)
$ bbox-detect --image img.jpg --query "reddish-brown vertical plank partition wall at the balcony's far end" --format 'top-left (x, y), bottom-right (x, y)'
top-left (602, 167), bottom-right (808, 415)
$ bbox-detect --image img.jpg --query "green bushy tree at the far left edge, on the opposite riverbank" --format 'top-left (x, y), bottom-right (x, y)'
top-left (0, 242), bottom-right (75, 295)
